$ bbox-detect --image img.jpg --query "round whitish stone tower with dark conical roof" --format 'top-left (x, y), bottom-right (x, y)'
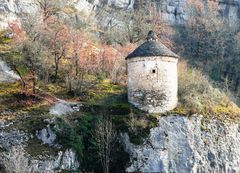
top-left (126, 31), bottom-right (178, 113)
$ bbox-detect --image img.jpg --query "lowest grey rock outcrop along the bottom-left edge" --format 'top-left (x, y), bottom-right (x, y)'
top-left (0, 145), bottom-right (79, 173)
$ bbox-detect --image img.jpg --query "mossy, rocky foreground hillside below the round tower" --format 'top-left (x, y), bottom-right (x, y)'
top-left (0, 63), bottom-right (240, 173)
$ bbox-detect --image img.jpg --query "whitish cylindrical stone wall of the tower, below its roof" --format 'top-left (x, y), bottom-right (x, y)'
top-left (128, 57), bottom-right (178, 113)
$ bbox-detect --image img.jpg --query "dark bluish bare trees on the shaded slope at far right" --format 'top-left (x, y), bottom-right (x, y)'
top-left (175, 0), bottom-right (240, 97)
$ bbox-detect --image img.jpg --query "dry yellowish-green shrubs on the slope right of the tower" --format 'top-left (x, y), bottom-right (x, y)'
top-left (177, 62), bottom-right (240, 115)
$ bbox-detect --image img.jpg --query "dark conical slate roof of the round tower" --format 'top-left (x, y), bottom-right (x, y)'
top-left (126, 39), bottom-right (179, 59)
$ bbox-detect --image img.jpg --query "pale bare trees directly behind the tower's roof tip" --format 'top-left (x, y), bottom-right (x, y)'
top-left (97, 1), bottom-right (173, 46)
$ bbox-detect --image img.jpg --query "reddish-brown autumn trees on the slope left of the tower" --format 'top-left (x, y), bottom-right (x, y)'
top-left (9, 10), bottom-right (134, 93)
